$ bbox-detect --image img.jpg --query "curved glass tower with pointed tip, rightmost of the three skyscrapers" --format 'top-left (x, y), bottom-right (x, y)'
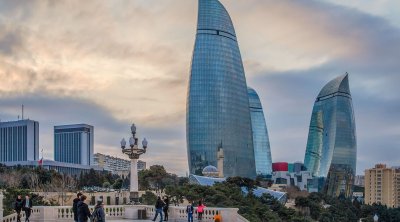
top-left (304, 73), bottom-right (357, 197)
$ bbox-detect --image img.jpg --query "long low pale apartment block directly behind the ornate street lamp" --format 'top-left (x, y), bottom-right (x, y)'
top-left (93, 153), bottom-right (146, 177)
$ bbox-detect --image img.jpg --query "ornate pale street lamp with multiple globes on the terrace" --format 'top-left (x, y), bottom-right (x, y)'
top-left (121, 124), bottom-right (148, 202)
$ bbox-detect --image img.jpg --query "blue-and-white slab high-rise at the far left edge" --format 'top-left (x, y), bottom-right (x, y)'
top-left (0, 119), bottom-right (39, 163)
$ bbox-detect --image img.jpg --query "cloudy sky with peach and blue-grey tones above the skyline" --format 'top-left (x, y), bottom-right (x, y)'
top-left (0, 0), bottom-right (400, 175)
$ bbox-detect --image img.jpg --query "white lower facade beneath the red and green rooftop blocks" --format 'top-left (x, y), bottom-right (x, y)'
top-left (272, 171), bottom-right (314, 192)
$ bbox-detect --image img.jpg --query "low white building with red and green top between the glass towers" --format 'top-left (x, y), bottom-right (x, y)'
top-left (271, 162), bottom-right (318, 192)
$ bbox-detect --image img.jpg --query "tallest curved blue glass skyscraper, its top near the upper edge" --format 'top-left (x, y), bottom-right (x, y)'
top-left (186, 0), bottom-right (256, 178)
